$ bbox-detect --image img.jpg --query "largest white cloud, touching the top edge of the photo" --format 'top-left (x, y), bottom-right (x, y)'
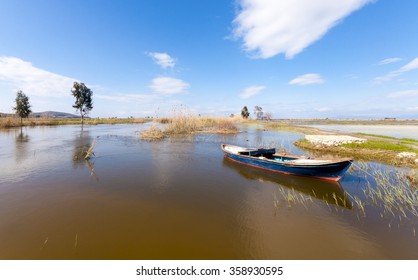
top-left (233, 0), bottom-right (374, 58)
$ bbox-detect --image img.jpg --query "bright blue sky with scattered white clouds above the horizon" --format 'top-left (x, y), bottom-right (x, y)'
top-left (0, 0), bottom-right (418, 119)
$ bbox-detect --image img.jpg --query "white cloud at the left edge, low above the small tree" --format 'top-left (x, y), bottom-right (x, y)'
top-left (0, 57), bottom-right (76, 97)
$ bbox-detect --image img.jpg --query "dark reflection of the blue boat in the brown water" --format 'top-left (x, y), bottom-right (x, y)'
top-left (223, 158), bottom-right (353, 209)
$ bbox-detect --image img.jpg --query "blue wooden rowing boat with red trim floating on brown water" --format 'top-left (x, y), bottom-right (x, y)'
top-left (221, 144), bottom-right (353, 181)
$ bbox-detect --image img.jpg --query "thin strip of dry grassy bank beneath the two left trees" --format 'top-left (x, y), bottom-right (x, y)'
top-left (0, 117), bottom-right (149, 128)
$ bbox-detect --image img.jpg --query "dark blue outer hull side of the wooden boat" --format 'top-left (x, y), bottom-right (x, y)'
top-left (223, 144), bottom-right (352, 181)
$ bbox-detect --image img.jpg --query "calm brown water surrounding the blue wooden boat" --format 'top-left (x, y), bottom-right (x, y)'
top-left (0, 124), bottom-right (418, 259)
